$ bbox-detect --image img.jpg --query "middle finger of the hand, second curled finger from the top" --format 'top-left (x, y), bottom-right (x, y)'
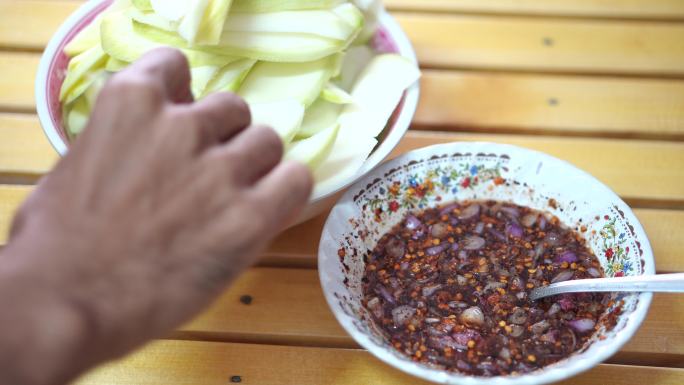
top-left (188, 92), bottom-right (252, 144)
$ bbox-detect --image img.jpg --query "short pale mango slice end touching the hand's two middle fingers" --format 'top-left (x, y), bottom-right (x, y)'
top-left (249, 100), bottom-right (304, 144)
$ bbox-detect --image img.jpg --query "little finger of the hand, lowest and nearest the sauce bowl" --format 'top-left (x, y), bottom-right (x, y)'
top-left (254, 162), bottom-right (313, 231)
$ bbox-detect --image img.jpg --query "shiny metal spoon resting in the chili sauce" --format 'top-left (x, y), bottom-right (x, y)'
top-left (529, 273), bottom-right (684, 301)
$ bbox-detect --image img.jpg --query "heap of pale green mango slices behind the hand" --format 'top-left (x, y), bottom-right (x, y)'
top-left (60, 0), bottom-right (420, 190)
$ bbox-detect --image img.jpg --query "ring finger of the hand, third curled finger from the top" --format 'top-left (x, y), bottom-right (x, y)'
top-left (208, 126), bottom-right (283, 185)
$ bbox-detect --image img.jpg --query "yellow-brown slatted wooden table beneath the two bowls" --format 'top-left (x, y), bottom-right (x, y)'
top-left (0, 0), bottom-right (684, 385)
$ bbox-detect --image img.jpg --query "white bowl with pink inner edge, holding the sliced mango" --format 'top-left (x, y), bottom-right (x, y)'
top-left (35, 0), bottom-right (419, 223)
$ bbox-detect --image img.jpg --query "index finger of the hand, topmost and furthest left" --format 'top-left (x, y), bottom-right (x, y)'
top-left (111, 47), bottom-right (193, 103)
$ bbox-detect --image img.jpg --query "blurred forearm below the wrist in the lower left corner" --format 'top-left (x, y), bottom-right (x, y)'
top-left (0, 244), bottom-right (92, 385)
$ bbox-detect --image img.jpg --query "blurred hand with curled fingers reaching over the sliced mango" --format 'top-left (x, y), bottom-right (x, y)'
top-left (3, 49), bottom-right (312, 380)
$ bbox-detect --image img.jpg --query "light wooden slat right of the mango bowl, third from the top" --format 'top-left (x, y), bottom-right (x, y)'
top-left (414, 70), bottom-right (684, 139)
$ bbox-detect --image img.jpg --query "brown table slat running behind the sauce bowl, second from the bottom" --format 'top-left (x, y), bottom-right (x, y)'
top-left (175, 268), bottom-right (684, 367)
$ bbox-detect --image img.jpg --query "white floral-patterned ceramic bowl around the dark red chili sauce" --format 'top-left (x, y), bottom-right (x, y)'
top-left (318, 143), bottom-right (655, 385)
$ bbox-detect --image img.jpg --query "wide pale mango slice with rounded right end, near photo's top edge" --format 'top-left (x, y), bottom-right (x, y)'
top-left (223, 4), bottom-right (363, 42)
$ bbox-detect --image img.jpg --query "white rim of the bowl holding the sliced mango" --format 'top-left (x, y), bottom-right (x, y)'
top-left (34, 0), bottom-right (420, 204)
